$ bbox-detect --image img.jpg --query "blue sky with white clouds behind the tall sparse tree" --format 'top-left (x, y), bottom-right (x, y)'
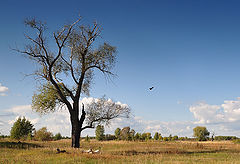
top-left (0, 0), bottom-right (240, 136)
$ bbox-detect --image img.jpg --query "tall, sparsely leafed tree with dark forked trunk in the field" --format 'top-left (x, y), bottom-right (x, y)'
top-left (15, 18), bottom-right (130, 148)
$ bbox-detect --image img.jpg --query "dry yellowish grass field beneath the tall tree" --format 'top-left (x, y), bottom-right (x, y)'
top-left (0, 140), bottom-right (240, 164)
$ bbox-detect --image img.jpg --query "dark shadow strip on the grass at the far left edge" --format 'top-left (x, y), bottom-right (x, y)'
top-left (0, 141), bottom-right (42, 149)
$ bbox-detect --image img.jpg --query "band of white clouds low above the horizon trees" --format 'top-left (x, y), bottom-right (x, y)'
top-left (0, 97), bottom-right (240, 137)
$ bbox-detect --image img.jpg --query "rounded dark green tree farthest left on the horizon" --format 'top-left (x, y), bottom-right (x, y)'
top-left (10, 117), bottom-right (34, 139)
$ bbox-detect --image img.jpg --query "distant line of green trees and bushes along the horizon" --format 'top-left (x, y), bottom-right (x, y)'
top-left (0, 117), bottom-right (238, 141)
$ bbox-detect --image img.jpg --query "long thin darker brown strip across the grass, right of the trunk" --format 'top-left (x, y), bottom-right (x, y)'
top-left (115, 150), bottom-right (233, 156)
